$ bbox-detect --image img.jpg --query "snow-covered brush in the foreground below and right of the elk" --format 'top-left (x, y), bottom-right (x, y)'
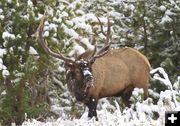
top-left (22, 68), bottom-right (180, 126)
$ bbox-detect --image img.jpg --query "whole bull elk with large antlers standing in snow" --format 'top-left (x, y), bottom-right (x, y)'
top-left (37, 17), bottom-right (150, 119)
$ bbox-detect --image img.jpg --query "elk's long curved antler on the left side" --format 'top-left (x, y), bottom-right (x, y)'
top-left (37, 16), bottom-right (74, 63)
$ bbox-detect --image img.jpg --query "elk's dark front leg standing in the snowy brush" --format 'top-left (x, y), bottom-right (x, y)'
top-left (86, 98), bottom-right (98, 120)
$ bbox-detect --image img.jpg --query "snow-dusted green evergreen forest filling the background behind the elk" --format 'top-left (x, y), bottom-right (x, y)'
top-left (0, 0), bottom-right (180, 124)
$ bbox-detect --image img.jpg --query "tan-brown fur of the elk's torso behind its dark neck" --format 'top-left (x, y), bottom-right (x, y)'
top-left (81, 48), bottom-right (150, 106)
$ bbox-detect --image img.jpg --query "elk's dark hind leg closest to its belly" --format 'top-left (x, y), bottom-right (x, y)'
top-left (122, 86), bottom-right (134, 107)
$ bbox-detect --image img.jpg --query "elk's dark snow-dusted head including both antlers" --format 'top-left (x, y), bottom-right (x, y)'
top-left (37, 16), bottom-right (111, 101)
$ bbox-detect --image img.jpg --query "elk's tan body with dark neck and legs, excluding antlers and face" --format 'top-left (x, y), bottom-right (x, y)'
top-left (67, 48), bottom-right (150, 117)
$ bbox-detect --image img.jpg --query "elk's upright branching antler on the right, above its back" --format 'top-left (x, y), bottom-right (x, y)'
top-left (89, 17), bottom-right (111, 62)
